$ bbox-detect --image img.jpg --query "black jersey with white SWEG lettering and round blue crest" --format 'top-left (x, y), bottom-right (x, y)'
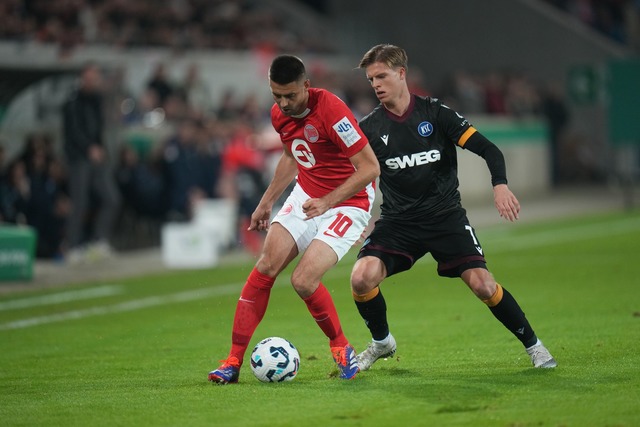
top-left (360, 94), bottom-right (476, 219)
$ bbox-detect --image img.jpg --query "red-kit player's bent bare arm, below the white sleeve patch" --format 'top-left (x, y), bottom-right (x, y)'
top-left (302, 144), bottom-right (380, 219)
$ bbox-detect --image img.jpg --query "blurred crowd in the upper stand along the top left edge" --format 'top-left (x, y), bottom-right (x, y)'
top-left (0, 0), bottom-right (333, 55)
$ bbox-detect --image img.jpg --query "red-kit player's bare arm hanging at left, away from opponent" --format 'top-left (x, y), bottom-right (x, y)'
top-left (248, 147), bottom-right (298, 231)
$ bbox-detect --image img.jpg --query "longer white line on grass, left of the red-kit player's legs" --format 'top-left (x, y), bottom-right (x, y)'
top-left (0, 283), bottom-right (242, 331)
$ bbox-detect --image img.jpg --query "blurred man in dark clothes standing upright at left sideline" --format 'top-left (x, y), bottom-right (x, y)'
top-left (62, 63), bottom-right (120, 263)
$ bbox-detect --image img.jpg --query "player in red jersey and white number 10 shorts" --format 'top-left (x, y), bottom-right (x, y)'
top-left (209, 55), bottom-right (380, 384)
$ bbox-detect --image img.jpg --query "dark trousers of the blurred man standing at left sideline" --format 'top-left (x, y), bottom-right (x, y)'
top-left (67, 160), bottom-right (120, 249)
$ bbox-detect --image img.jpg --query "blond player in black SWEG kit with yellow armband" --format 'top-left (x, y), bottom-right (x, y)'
top-left (351, 44), bottom-right (556, 371)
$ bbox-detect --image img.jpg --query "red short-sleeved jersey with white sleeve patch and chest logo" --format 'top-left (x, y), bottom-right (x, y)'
top-left (271, 88), bottom-right (374, 211)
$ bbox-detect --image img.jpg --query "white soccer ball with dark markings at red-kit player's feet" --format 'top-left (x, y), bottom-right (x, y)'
top-left (251, 337), bottom-right (300, 383)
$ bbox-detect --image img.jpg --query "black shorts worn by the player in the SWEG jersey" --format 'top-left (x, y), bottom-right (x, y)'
top-left (358, 207), bottom-right (487, 277)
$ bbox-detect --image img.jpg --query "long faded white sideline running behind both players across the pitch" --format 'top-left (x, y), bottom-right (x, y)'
top-left (0, 218), bottom-right (640, 331)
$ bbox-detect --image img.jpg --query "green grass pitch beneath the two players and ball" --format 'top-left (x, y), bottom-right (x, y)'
top-left (0, 211), bottom-right (640, 427)
